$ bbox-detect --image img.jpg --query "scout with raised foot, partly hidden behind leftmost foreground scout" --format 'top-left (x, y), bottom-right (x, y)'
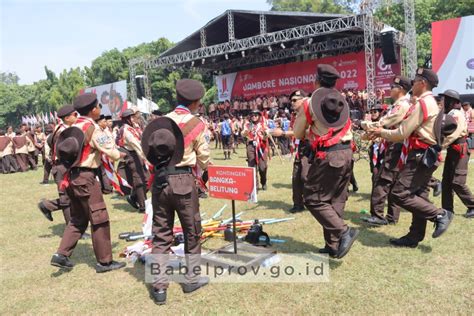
top-left (38, 104), bottom-right (77, 225)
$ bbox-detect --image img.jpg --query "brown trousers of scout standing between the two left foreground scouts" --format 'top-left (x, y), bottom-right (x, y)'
top-left (117, 149), bottom-right (148, 209)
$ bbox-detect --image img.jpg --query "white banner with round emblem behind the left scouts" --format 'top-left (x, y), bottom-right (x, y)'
top-left (82, 80), bottom-right (127, 120)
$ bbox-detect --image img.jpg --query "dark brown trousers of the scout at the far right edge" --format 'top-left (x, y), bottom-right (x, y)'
top-left (441, 146), bottom-right (474, 212)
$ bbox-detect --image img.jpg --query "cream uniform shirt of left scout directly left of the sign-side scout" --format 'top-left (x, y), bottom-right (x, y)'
top-left (73, 117), bottom-right (120, 169)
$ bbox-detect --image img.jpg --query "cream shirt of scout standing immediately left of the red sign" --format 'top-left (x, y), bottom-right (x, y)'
top-left (166, 110), bottom-right (211, 170)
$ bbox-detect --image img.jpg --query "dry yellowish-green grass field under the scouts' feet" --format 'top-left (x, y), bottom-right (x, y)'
top-left (0, 149), bottom-right (474, 315)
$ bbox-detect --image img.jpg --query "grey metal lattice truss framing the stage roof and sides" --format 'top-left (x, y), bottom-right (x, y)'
top-left (129, 10), bottom-right (416, 107)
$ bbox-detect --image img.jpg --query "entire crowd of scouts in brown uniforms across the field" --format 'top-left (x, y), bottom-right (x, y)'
top-left (0, 65), bottom-right (474, 304)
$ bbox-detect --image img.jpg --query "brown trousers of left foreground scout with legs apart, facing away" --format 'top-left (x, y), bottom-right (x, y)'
top-left (57, 168), bottom-right (112, 264)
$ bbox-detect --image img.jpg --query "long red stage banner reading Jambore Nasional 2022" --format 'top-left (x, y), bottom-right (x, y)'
top-left (216, 49), bottom-right (401, 101)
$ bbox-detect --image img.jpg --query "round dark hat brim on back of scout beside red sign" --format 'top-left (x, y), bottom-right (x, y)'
top-left (142, 116), bottom-right (184, 166)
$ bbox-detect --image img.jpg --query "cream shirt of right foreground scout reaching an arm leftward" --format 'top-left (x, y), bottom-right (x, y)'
top-left (382, 91), bottom-right (439, 145)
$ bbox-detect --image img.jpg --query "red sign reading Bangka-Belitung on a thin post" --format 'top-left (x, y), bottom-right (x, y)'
top-left (207, 165), bottom-right (257, 202)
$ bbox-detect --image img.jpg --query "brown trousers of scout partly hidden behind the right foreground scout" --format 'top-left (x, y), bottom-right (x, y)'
top-left (370, 143), bottom-right (402, 223)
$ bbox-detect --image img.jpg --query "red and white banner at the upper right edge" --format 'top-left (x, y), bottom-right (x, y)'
top-left (431, 15), bottom-right (474, 94)
